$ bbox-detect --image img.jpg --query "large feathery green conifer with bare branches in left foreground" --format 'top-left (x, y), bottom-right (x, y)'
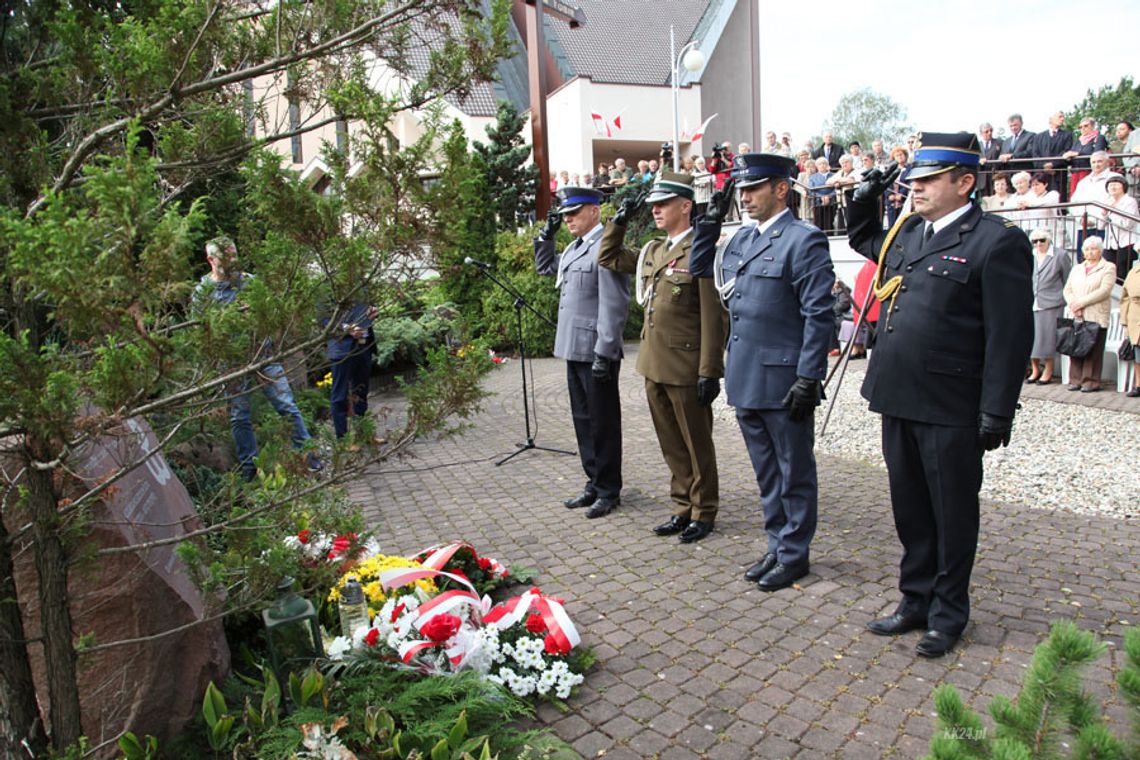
top-left (0, 0), bottom-right (508, 757)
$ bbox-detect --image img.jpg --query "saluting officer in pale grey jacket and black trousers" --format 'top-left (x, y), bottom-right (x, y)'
top-left (535, 187), bottom-right (629, 518)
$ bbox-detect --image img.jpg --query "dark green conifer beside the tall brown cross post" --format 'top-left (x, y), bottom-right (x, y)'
top-left (473, 100), bottom-right (538, 230)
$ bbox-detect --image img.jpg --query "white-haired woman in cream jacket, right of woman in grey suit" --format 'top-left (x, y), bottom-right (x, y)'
top-left (1065, 237), bottom-right (1116, 393)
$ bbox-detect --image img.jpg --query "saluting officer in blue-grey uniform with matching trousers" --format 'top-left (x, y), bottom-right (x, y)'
top-left (690, 153), bottom-right (836, 591)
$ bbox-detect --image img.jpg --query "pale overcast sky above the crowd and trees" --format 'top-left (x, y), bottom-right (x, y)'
top-left (757, 0), bottom-right (1140, 146)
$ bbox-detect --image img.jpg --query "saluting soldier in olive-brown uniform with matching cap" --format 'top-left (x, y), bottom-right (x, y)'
top-left (597, 172), bottom-right (726, 544)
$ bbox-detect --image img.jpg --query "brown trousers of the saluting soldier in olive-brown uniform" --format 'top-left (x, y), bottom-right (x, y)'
top-left (645, 379), bottom-right (720, 525)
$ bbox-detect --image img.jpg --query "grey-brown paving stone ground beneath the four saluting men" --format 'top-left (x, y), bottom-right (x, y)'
top-left (349, 346), bottom-right (1140, 760)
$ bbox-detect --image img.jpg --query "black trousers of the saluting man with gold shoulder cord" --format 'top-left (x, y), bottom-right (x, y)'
top-left (882, 415), bottom-right (983, 636)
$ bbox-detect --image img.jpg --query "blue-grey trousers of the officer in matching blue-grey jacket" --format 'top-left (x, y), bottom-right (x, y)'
top-left (736, 409), bottom-right (820, 564)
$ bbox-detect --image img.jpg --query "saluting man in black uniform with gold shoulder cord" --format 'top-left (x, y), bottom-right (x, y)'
top-left (849, 132), bottom-right (1033, 657)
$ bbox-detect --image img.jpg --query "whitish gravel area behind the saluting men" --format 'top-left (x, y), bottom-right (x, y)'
top-left (716, 361), bottom-right (1140, 518)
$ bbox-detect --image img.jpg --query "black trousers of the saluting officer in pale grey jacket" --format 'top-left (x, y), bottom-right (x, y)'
top-left (567, 361), bottom-right (621, 499)
